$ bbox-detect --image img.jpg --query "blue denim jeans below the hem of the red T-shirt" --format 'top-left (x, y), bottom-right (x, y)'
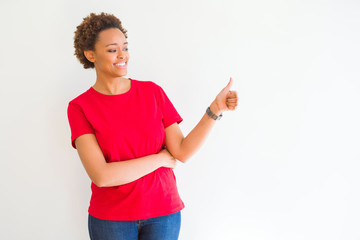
top-left (88, 211), bottom-right (181, 240)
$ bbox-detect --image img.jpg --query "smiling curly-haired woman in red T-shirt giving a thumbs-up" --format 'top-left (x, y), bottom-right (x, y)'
top-left (68, 13), bottom-right (237, 240)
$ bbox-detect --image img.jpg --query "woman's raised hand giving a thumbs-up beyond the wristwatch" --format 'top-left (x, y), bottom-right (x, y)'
top-left (210, 77), bottom-right (238, 115)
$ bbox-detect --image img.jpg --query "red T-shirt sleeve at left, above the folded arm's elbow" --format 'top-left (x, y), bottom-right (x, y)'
top-left (67, 102), bottom-right (95, 149)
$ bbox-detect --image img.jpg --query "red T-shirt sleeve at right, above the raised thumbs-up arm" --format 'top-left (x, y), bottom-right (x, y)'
top-left (157, 86), bottom-right (183, 128)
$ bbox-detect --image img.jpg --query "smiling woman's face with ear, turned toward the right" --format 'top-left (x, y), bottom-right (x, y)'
top-left (84, 28), bottom-right (129, 78)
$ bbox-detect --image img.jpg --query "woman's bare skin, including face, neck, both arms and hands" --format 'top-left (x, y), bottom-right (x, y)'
top-left (75, 28), bottom-right (238, 187)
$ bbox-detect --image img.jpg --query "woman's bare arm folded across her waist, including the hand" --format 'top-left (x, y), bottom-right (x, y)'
top-left (75, 134), bottom-right (176, 187)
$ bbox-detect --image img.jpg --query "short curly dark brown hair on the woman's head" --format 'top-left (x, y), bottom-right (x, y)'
top-left (74, 12), bottom-right (127, 69)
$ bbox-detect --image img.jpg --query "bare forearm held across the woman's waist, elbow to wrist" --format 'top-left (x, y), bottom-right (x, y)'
top-left (100, 154), bottom-right (163, 187)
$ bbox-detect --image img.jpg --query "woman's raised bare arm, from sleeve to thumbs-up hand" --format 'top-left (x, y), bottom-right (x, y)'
top-left (165, 78), bottom-right (238, 163)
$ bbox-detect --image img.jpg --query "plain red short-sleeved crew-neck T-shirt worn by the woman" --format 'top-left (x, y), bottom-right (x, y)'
top-left (68, 79), bottom-right (184, 220)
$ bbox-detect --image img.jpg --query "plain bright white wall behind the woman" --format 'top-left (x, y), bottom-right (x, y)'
top-left (0, 0), bottom-right (360, 240)
